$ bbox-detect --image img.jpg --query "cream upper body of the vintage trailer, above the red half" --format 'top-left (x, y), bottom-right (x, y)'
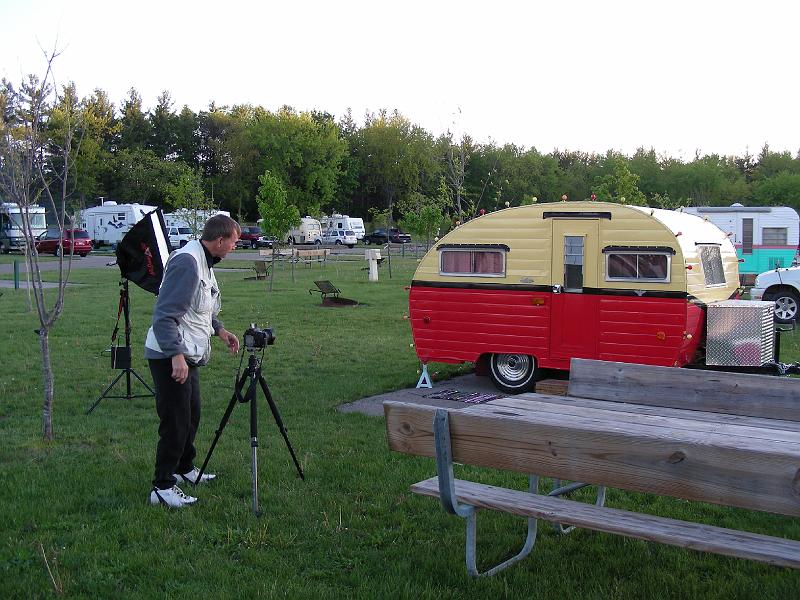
top-left (415, 202), bottom-right (737, 302)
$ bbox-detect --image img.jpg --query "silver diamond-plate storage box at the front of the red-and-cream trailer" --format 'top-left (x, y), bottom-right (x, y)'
top-left (706, 300), bottom-right (775, 367)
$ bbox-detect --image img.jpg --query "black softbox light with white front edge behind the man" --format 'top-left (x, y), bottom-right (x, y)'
top-left (117, 209), bottom-right (172, 295)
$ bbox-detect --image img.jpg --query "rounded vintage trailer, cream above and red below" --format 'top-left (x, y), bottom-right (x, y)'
top-left (409, 202), bottom-right (739, 392)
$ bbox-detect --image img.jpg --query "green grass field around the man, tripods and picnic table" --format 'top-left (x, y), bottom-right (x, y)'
top-left (0, 256), bottom-right (800, 599)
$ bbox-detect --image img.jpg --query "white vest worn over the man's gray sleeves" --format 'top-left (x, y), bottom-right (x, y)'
top-left (144, 240), bottom-right (220, 365)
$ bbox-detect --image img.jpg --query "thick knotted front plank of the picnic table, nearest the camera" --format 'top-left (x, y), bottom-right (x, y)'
top-left (384, 402), bottom-right (800, 516)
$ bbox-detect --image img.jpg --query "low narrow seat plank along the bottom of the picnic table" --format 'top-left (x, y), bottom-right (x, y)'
top-left (411, 477), bottom-right (800, 569)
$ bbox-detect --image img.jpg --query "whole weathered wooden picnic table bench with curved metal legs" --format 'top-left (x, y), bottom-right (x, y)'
top-left (384, 359), bottom-right (800, 577)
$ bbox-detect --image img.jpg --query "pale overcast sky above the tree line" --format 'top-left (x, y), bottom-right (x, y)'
top-left (0, 0), bottom-right (800, 159)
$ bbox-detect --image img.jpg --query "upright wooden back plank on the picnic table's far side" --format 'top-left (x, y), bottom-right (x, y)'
top-left (568, 358), bottom-right (800, 421)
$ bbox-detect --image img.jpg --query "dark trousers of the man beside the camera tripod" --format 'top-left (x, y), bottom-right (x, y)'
top-left (148, 358), bottom-right (200, 490)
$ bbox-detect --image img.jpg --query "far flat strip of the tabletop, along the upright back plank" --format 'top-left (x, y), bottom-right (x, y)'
top-left (512, 392), bottom-right (800, 433)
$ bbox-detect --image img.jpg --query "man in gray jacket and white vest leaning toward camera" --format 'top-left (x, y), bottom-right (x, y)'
top-left (145, 215), bottom-right (241, 508)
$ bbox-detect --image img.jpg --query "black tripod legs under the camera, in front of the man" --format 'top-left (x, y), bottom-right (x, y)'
top-left (196, 348), bottom-right (306, 516)
